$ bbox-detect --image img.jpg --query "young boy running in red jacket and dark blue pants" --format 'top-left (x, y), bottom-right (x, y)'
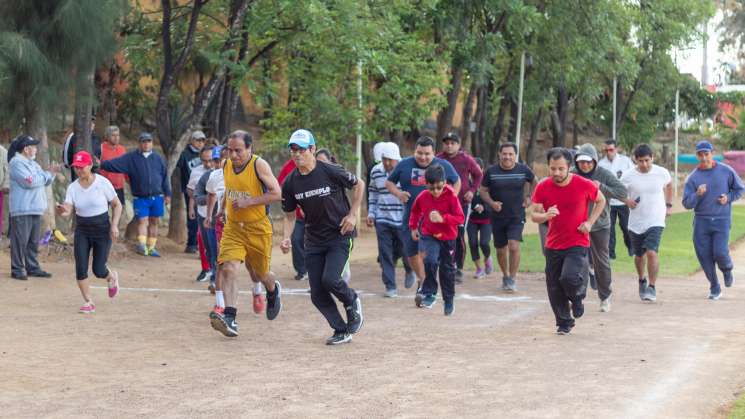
top-left (409, 164), bottom-right (465, 316)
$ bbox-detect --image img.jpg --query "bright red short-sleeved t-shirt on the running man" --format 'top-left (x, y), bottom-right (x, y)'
top-left (533, 175), bottom-right (598, 250)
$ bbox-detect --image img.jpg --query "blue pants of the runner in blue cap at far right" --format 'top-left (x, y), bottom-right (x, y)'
top-left (693, 216), bottom-right (732, 291)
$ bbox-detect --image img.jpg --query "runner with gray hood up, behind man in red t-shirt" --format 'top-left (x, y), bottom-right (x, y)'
top-left (573, 144), bottom-right (626, 313)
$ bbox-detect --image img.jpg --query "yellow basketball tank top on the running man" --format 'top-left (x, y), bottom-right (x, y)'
top-left (223, 154), bottom-right (271, 232)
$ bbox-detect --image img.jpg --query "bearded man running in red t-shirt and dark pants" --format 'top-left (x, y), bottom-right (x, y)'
top-left (531, 148), bottom-right (605, 335)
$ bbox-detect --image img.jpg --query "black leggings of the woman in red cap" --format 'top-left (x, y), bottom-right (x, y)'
top-left (75, 212), bottom-right (111, 281)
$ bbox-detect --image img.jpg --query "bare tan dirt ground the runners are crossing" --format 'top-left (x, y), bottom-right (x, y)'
top-left (0, 236), bottom-right (745, 418)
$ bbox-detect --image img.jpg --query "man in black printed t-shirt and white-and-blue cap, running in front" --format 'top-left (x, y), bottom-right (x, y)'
top-left (280, 129), bottom-right (365, 345)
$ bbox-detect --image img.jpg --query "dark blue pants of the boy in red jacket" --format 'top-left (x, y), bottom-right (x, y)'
top-left (419, 236), bottom-right (455, 301)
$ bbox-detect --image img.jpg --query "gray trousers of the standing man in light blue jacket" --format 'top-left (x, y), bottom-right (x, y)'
top-left (10, 215), bottom-right (41, 276)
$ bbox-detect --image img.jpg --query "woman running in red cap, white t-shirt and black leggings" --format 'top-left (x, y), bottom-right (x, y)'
top-left (57, 151), bottom-right (122, 314)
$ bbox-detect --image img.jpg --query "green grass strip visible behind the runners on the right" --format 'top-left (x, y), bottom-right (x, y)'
top-left (466, 205), bottom-right (745, 276)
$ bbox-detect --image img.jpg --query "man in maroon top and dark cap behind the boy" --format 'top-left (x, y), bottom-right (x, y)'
top-left (437, 132), bottom-right (484, 284)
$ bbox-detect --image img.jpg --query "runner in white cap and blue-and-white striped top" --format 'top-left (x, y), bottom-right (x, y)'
top-left (367, 143), bottom-right (416, 298)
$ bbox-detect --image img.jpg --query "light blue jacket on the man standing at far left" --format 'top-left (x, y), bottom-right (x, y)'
top-left (10, 153), bottom-right (54, 217)
